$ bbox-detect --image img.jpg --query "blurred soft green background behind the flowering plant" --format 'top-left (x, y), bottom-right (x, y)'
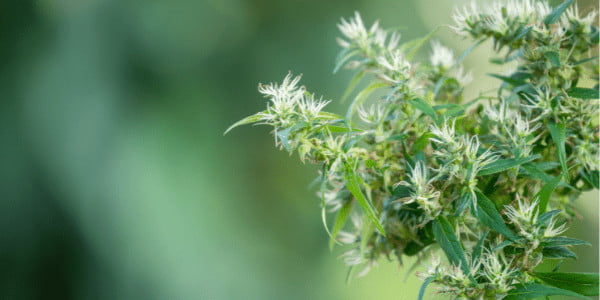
top-left (0, 0), bottom-right (598, 299)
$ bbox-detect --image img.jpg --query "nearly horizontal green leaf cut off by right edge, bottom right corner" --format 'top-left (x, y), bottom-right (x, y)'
top-left (534, 272), bottom-right (598, 296)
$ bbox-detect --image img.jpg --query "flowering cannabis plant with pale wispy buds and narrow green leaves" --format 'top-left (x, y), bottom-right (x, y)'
top-left (228, 0), bottom-right (599, 299)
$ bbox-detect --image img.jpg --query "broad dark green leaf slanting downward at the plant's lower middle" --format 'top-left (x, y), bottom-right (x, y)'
top-left (433, 216), bottom-right (470, 274)
